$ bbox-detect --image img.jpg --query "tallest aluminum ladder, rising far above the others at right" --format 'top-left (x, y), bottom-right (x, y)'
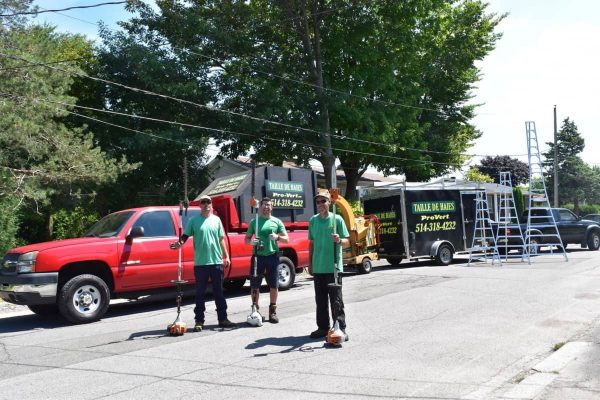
top-left (525, 121), bottom-right (569, 261)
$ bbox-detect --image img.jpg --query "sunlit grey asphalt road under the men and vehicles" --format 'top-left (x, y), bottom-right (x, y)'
top-left (0, 249), bottom-right (600, 400)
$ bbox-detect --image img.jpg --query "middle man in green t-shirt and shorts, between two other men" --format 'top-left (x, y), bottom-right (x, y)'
top-left (246, 197), bottom-right (289, 324)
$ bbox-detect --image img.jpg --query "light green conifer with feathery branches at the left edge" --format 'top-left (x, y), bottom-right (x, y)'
top-left (0, 11), bottom-right (134, 241)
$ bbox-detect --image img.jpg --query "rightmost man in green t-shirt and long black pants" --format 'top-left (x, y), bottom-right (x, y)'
top-left (308, 191), bottom-right (350, 340)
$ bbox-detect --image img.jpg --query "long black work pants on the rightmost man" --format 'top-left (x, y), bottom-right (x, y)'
top-left (313, 273), bottom-right (346, 331)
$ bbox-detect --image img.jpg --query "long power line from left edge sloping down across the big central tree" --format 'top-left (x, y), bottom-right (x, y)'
top-left (0, 53), bottom-right (524, 159)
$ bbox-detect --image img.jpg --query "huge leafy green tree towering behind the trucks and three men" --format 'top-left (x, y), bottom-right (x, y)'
top-left (117, 0), bottom-right (502, 198)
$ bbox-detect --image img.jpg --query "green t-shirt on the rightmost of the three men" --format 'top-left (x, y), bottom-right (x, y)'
top-left (308, 213), bottom-right (350, 274)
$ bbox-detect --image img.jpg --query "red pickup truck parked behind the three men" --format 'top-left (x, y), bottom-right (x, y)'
top-left (0, 195), bottom-right (308, 323)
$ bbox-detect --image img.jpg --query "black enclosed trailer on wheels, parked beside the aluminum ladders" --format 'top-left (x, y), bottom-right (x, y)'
top-left (363, 187), bottom-right (476, 265)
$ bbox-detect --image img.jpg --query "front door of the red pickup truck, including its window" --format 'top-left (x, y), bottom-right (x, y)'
top-left (117, 209), bottom-right (178, 290)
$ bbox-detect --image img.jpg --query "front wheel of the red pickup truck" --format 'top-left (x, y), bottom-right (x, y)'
top-left (58, 274), bottom-right (110, 324)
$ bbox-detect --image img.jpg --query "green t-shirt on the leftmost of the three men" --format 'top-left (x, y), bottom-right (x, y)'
top-left (184, 215), bottom-right (225, 265)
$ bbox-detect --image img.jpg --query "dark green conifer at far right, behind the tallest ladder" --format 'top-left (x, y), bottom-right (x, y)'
top-left (543, 118), bottom-right (600, 212)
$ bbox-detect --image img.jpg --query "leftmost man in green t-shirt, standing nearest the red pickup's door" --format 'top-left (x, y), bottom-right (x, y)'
top-left (171, 195), bottom-right (234, 332)
